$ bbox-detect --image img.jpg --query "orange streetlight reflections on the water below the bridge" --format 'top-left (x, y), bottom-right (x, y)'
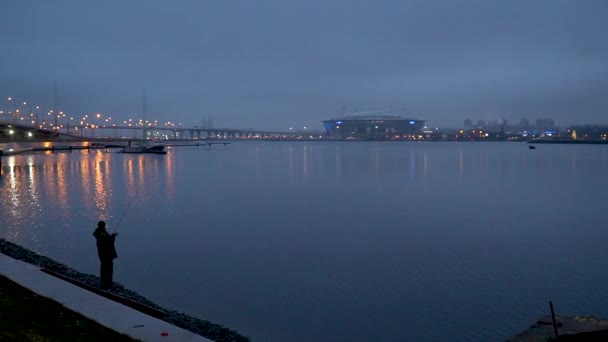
top-left (0, 151), bottom-right (167, 241)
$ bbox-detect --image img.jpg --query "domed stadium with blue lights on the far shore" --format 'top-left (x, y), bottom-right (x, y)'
top-left (323, 111), bottom-right (426, 140)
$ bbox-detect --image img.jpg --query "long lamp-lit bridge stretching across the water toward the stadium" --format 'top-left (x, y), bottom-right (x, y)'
top-left (0, 121), bottom-right (323, 141)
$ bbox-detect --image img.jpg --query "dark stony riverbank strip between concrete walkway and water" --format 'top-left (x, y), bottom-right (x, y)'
top-left (0, 239), bottom-right (249, 342)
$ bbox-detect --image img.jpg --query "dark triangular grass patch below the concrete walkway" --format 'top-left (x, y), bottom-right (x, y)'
top-left (0, 275), bottom-right (137, 342)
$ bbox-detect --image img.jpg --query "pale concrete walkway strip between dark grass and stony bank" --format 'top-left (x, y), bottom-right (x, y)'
top-left (0, 253), bottom-right (211, 342)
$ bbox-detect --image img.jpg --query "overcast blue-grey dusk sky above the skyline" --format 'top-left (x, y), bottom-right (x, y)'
top-left (0, 0), bottom-right (608, 129)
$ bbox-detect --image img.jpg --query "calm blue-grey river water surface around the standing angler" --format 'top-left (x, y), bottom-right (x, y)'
top-left (0, 142), bottom-right (608, 341)
